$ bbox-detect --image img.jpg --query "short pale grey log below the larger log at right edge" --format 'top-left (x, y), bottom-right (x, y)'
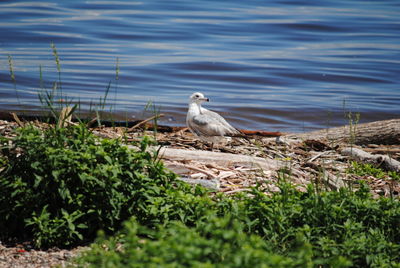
top-left (341, 148), bottom-right (400, 172)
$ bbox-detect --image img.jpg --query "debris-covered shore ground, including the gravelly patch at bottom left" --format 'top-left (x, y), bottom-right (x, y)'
top-left (0, 120), bottom-right (400, 267)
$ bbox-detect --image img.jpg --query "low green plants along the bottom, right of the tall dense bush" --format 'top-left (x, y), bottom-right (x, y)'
top-left (76, 183), bottom-right (400, 267)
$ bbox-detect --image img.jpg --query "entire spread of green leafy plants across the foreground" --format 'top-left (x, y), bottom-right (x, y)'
top-left (0, 126), bottom-right (400, 267)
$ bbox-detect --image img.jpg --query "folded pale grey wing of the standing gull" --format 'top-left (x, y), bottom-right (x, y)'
top-left (188, 109), bottom-right (239, 136)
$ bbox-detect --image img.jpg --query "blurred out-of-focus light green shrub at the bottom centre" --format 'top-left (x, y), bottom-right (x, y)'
top-left (76, 216), bottom-right (318, 267)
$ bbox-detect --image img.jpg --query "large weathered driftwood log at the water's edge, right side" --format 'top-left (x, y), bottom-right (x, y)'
top-left (284, 119), bottom-right (400, 145)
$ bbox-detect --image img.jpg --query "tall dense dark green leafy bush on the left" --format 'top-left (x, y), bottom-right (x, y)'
top-left (0, 126), bottom-right (175, 247)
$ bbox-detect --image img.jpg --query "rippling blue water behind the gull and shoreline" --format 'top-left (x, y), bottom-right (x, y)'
top-left (0, 0), bottom-right (400, 131)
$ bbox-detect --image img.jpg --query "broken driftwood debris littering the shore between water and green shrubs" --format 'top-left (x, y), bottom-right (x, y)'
top-left (0, 118), bottom-right (400, 196)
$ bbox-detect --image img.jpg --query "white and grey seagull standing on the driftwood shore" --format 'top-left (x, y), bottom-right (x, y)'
top-left (186, 92), bottom-right (240, 148)
